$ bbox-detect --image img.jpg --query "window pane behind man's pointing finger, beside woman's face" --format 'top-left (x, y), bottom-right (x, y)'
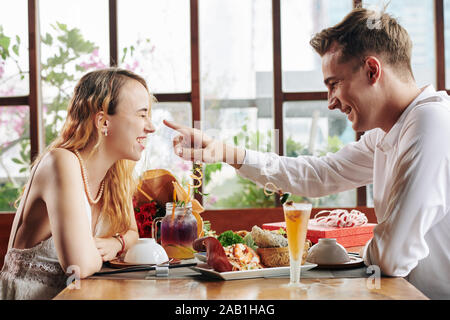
top-left (136, 102), bottom-right (192, 185)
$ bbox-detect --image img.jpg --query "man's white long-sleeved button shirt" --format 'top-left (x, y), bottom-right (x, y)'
top-left (237, 86), bottom-right (450, 299)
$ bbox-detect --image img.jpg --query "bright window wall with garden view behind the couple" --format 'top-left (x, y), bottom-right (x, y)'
top-left (0, 0), bottom-right (450, 211)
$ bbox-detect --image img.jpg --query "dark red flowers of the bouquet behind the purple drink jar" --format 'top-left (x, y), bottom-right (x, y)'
top-left (133, 198), bottom-right (165, 238)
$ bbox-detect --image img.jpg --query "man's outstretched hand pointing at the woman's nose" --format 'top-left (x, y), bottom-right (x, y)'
top-left (163, 120), bottom-right (245, 169)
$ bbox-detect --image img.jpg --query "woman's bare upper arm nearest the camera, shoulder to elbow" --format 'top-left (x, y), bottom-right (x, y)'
top-left (40, 149), bottom-right (102, 278)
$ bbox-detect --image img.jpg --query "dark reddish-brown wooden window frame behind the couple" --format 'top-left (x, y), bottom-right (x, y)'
top-left (0, 0), bottom-right (450, 212)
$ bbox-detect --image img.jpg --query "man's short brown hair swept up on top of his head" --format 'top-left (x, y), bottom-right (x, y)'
top-left (310, 8), bottom-right (414, 79)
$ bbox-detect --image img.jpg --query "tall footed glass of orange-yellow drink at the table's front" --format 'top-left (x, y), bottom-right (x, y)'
top-left (283, 201), bottom-right (312, 287)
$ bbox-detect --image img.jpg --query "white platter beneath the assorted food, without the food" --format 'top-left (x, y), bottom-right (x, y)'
top-left (191, 262), bottom-right (317, 280)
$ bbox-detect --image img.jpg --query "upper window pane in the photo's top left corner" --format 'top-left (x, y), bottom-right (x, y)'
top-left (0, 0), bottom-right (29, 97)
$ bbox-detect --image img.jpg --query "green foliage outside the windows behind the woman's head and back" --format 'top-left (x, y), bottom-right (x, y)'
top-left (0, 22), bottom-right (139, 211)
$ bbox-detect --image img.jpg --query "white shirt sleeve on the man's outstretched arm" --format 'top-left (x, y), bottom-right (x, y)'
top-left (237, 129), bottom-right (378, 197)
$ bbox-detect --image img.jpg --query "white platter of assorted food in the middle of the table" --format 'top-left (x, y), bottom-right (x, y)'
top-left (191, 226), bottom-right (317, 280)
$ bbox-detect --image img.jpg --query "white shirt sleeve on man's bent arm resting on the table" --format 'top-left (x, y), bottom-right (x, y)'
top-left (363, 104), bottom-right (450, 277)
